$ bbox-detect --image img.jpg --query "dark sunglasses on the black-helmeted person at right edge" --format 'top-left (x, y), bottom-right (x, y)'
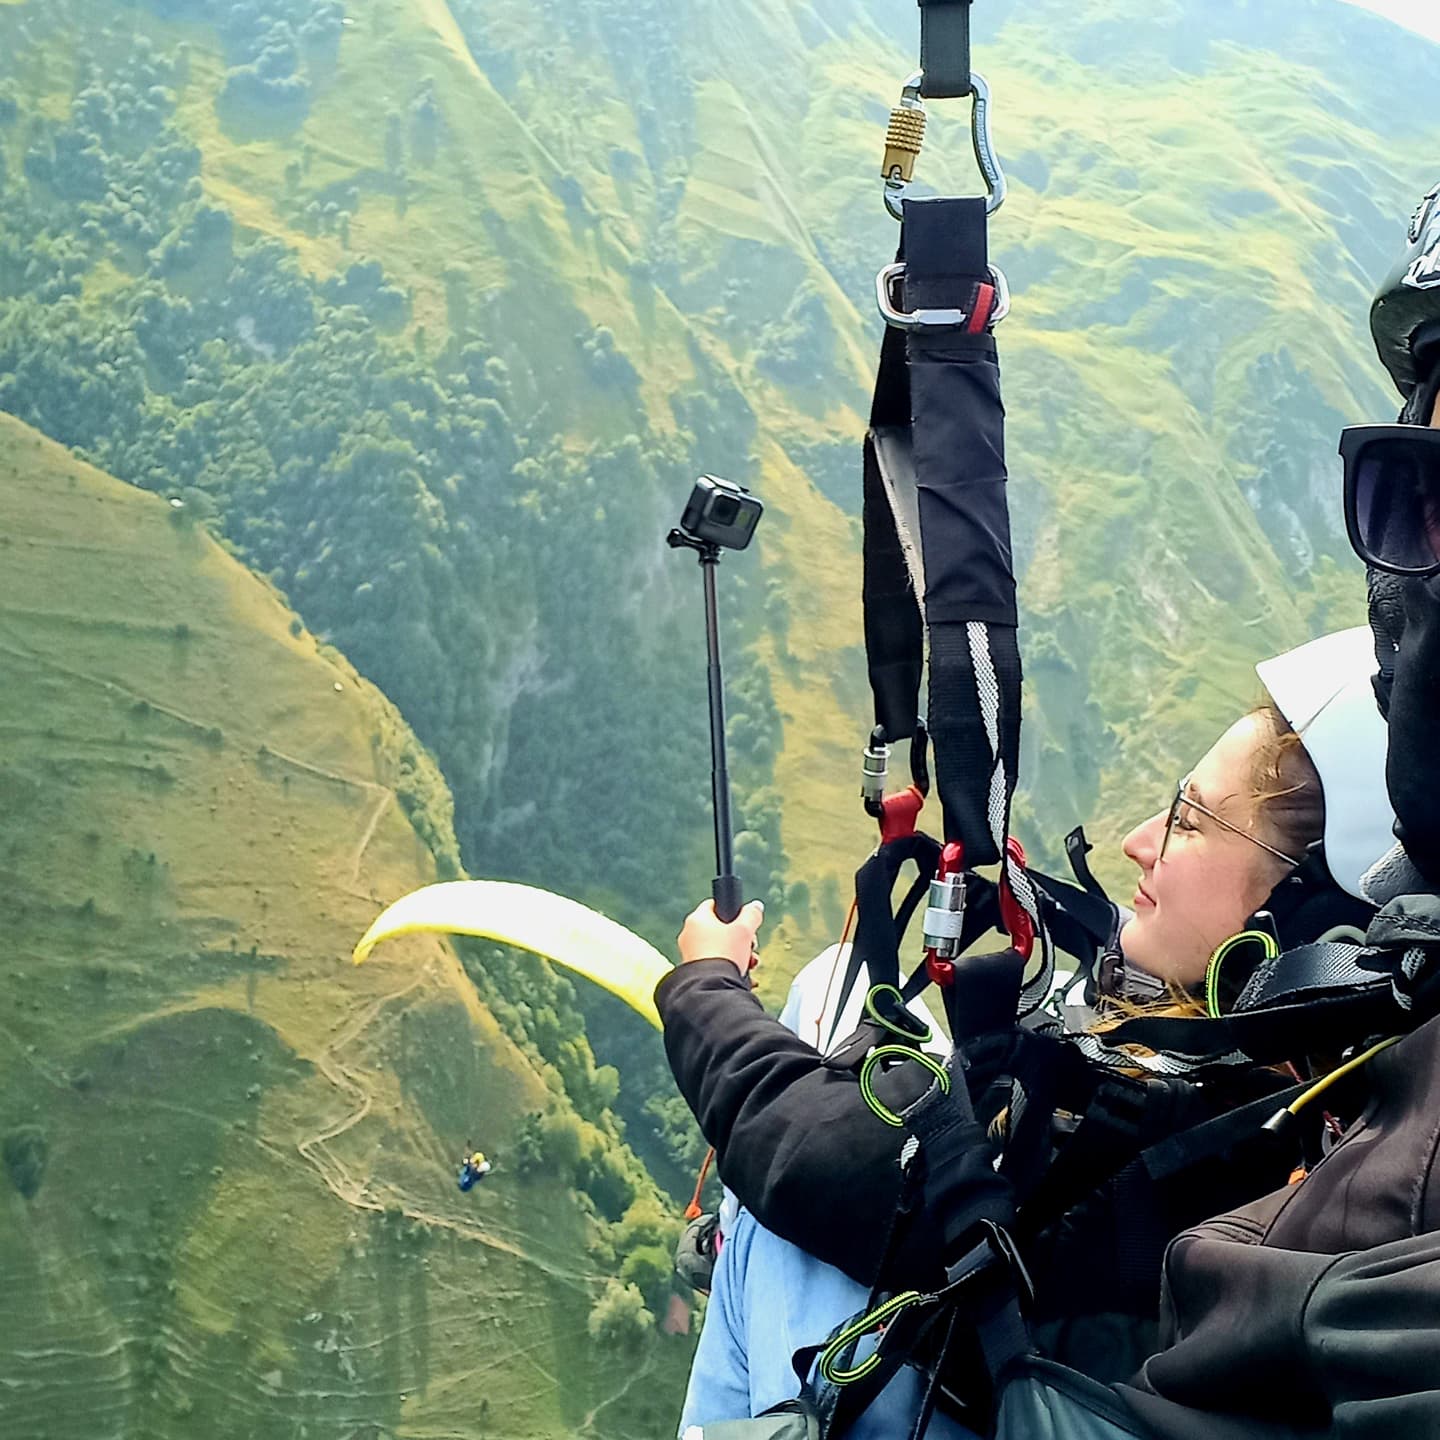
top-left (1341, 425), bottom-right (1440, 575)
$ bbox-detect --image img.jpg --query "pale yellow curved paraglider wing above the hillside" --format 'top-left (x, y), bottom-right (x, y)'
top-left (354, 880), bottom-right (671, 1030)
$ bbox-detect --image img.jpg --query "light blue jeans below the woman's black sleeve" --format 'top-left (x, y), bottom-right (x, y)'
top-left (680, 1210), bottom-right (973, 1440)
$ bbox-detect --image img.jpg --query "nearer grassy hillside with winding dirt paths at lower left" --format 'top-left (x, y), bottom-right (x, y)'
top-left (0, 416), bottom-right (685, 1440)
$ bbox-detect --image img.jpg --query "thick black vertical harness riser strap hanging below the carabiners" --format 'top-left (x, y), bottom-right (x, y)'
top-left (864, 194), bottom-right (1021, 868)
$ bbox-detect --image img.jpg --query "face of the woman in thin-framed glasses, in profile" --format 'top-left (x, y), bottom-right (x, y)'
top-left (1120, 716), bottom-right (1287, 989)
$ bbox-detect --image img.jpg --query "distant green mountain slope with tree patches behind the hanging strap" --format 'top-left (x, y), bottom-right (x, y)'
top-left (0, 0), bottom-right (1440, 976)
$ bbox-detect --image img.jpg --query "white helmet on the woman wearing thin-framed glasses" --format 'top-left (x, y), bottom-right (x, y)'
top-left (1256, 630), bottom-right (1393, 898)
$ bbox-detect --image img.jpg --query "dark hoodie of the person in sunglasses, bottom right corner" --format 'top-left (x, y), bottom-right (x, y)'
top-left (1122, 896), bottom-right (1440, 1440)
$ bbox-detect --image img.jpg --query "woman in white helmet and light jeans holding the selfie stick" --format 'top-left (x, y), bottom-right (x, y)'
top-left (657, 631), bottom-right (1391, 1436)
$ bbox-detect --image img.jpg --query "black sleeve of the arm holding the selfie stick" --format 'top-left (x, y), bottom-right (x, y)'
top-left (655, 960), bottom-right (930, 1284)
